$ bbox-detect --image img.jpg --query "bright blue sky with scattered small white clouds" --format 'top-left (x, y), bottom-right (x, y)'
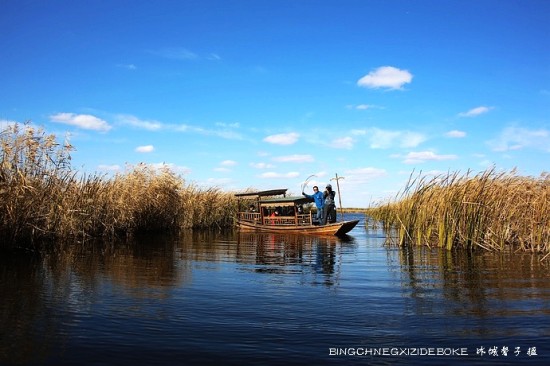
top-left (0, 0), bottom-right (550, 207)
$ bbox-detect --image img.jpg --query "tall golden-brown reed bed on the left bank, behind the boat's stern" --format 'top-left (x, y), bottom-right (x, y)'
top-left (0, 124), bottom-right (237, 249)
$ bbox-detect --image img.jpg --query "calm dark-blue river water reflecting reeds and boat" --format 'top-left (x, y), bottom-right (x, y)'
top-left (0, 213), bottom-right (550, 365)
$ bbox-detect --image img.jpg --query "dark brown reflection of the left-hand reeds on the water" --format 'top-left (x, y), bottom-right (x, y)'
top-left (0, 236), bottom-right (191, 364)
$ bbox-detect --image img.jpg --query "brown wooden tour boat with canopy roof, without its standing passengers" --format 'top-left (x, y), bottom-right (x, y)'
top-left (235, 189), bottom-right (359, 236)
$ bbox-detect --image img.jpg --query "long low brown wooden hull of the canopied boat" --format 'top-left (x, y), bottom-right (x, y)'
top-left (237, 220), bottom-right (359, 236)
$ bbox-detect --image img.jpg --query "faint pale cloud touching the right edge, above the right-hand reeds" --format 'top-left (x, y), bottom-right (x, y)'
top-left (488, 127), bottom-right (550, 152)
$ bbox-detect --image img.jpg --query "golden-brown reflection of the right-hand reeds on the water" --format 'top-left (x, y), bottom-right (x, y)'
top-left (388, 246), bottom-right (550, 337)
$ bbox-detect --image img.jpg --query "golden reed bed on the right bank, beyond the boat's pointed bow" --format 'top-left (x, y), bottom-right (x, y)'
top-left (367, 169), bottom-right (550, 253)
